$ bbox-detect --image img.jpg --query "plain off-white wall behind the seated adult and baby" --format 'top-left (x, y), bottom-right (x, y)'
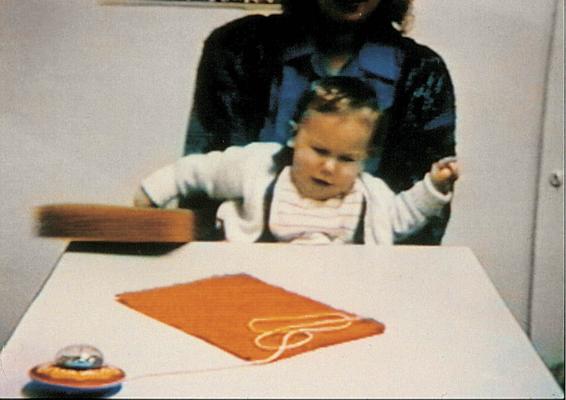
top-left (0, 0), bottom-right (555, 368)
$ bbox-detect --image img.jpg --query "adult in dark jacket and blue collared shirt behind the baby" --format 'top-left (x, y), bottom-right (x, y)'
top-left (185, 0), bottom-right (455, 244)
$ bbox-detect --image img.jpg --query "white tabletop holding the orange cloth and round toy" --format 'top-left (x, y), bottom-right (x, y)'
top-left (0, 242), bottom-right (563, 398)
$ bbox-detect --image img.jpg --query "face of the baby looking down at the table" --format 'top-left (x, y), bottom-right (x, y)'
top-left (291, 113), bottom-right (373, 200)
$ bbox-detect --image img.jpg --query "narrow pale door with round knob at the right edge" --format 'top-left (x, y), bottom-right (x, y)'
top-left (530, 1), bottom-right (564, 365)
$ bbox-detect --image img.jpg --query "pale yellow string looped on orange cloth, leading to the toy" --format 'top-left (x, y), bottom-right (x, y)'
top-left (125, 312), bottom-right (359, 382)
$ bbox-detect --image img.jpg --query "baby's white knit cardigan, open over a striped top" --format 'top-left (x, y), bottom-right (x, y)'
top-left (142, 143), bottom-right (452, 244)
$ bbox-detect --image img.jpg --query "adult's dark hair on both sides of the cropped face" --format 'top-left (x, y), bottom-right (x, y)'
top-left (281, 0), bottom-right (413, 35)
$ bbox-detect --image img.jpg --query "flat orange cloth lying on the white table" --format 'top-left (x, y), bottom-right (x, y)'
top-left (117, 274), bottom-right (385, 361)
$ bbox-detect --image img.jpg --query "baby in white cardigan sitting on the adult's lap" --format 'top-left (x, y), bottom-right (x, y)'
top-left (134, 77), bottom-right (458, 244)
